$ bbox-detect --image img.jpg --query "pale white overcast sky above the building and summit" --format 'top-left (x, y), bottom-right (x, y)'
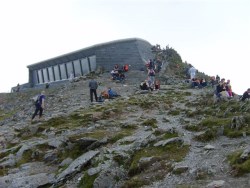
top-left (0, 0), bottom-right (250, 94)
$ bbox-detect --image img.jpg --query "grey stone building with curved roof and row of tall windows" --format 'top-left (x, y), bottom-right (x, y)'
top-left (28, 38), bottom-right (153, 86)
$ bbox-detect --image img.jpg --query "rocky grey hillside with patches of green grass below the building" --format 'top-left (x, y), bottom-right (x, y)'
top-left (0, 71), bottom-right (250, 188)
